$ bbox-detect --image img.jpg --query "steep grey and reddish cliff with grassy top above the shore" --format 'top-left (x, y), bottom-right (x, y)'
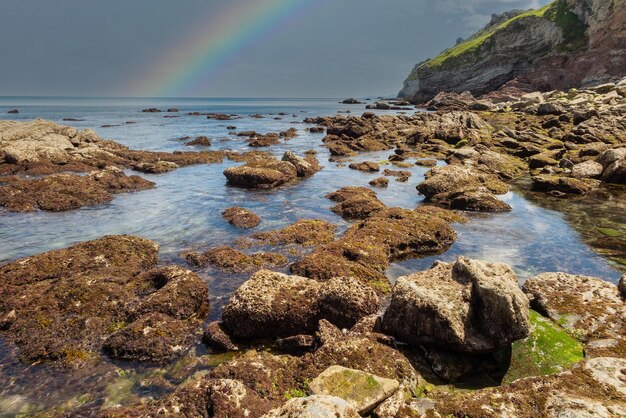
top-left (399, 0), bottom-right (626, 102)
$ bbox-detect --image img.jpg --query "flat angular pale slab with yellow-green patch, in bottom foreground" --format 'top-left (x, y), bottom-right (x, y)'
top-left (309, 366), bottom-right (400, 414)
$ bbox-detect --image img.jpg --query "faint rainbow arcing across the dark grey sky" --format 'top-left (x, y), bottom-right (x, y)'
top-left (123, 0), bottom-right (324, 97)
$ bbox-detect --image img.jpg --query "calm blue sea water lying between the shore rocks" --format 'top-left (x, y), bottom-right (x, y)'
top-left (0, 98), bottom-right (621, 415)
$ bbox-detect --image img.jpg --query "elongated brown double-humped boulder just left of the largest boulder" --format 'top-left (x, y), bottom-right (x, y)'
top-left (222, 270), bottom-right (379, 338)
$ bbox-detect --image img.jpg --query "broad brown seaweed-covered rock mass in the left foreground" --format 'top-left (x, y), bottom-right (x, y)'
top-left (0, 236), bottom-right (209, 367)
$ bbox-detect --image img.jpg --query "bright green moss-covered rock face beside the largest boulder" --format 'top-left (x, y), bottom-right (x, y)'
top-left (503, 311), bottom-right (584, 383)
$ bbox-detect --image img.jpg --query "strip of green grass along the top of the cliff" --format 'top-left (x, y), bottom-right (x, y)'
top-left (409, 0), bottom-right (587, 74)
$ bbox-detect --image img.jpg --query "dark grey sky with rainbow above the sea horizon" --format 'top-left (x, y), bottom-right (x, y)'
top-left (0, 0), bottom-right (548, 97)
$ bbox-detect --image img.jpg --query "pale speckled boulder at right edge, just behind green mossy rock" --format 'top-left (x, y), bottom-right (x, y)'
top-left (523, 273), bottom-right (626, 357)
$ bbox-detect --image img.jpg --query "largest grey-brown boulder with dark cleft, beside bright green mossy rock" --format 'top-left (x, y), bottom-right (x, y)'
top-left (382, 257), bottom-right (530, 353)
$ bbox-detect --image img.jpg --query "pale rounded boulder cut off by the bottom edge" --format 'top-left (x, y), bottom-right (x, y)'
top-left (261, 395), bottom-right (360, 418)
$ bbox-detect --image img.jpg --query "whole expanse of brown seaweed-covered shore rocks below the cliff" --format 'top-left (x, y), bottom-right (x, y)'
top-left (0, 80), bottom-right (626, 418)
